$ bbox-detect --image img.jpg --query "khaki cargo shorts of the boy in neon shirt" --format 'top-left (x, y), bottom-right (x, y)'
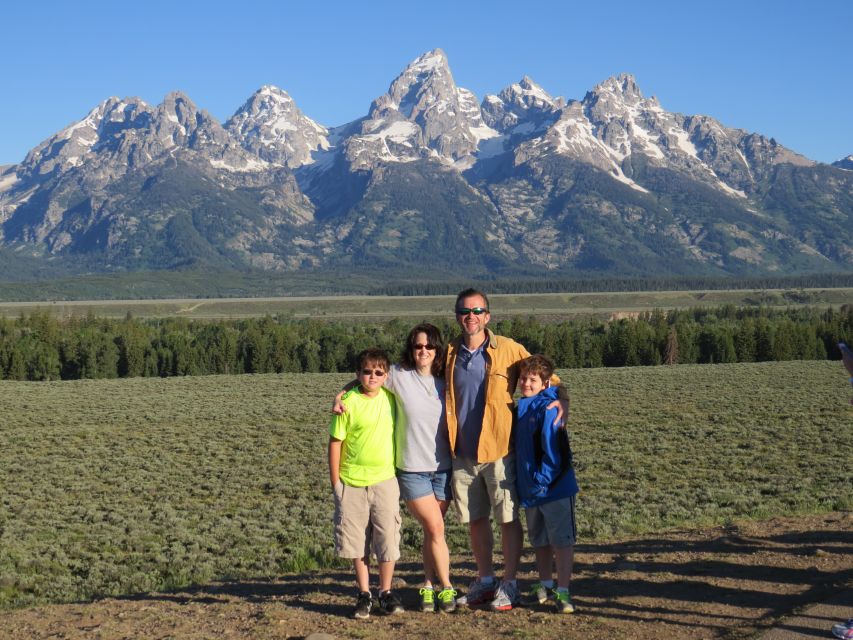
top-left (335, 478), bottom-right (400, 562)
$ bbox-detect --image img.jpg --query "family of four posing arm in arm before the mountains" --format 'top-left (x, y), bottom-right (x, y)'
top-left (328, 289), bottom-right (578, 618)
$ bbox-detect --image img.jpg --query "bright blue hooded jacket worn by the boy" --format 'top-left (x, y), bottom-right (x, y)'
top-left (513, 387), bottom-right (579, 507)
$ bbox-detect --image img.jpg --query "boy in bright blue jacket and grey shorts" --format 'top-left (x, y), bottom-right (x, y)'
top-left (513, 355), bottom-right (578, 613)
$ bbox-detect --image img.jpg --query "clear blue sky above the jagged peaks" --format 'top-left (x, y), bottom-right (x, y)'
top-left (0, 0), bottom-right (853, 164)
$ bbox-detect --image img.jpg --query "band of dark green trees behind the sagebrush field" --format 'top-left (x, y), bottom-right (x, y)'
top-left (0, 305), bottom-right (853, 381)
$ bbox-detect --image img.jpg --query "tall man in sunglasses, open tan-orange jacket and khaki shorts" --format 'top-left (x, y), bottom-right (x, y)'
top-left (445, 289), bottom-right (568, 611)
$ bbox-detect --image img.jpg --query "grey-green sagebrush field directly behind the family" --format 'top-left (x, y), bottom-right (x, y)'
top-left (0, 361), bottom-right (853, 608)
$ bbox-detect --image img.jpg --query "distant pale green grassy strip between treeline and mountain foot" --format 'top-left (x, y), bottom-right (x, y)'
top-left (0, 288), bottom-right (853, 320)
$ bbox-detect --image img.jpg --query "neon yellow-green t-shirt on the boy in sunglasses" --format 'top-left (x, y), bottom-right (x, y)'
top-left (329, 387), bottom-right (395, 487)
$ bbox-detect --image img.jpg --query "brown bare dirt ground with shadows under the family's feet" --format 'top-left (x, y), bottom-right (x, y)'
top-left (0, 513), bottom-right (853, 640)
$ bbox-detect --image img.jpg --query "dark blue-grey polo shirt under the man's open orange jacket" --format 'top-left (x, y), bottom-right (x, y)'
top-left (453, 340), bottom-right (488, 460)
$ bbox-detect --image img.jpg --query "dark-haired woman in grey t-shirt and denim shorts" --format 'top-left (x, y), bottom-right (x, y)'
top-left (334, 323), bottom-right (456, 613)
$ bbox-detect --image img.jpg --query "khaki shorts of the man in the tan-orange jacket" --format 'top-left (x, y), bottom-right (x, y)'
top-left (453, 453), bottom-right (518, 524)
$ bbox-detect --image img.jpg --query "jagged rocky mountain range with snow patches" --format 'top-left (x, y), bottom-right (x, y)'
top-left (0, 49), bottom-right (853, 279)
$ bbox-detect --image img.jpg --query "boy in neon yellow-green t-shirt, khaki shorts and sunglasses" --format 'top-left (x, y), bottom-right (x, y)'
top-left (329, 349), bottom-right (403, 618)
